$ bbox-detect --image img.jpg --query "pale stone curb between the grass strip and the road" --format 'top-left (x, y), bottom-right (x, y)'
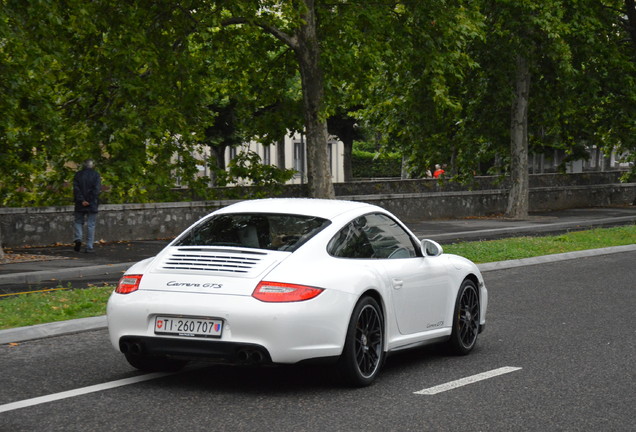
top-left (0, 244), bottom-right (636, 345)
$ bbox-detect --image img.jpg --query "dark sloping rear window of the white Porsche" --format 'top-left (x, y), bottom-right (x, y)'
top-left (175, 213), bottom-right (331, 252)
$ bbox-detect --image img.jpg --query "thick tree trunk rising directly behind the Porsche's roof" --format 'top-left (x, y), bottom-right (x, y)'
top-left (295, 0), bottom-right (335, 198)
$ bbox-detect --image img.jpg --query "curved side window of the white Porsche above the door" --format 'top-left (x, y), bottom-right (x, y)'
top-left (327, 213), bottom-right (417, 259)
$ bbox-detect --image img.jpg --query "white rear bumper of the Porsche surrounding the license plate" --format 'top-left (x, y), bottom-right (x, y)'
top-left (107, 290), bottom-right (355, 363)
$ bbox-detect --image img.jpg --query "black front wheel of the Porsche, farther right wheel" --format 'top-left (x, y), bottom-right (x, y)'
top-left (448, 279), bottom-right (480, 355)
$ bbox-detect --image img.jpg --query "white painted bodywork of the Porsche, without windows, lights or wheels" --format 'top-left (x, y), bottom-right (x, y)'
top-left (107, 199), bottom-right (488, 363)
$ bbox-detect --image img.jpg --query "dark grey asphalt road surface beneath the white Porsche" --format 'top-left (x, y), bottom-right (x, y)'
top-left (0, 252), bottom-right (636, 432)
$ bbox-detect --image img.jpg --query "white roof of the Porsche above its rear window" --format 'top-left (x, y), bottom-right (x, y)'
top-left (219, 198), bottom-right (379, 219)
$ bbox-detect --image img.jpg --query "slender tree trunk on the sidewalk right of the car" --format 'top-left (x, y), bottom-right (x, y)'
top-left (506, 56), bottom-right (530, 219)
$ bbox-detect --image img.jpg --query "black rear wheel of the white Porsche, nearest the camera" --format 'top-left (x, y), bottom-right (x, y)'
top-left (338, 297), bottom-right (385, 387)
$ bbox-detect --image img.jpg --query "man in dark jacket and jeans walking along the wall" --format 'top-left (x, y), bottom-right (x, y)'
top-left (73, 159), bottom-right (102, 253)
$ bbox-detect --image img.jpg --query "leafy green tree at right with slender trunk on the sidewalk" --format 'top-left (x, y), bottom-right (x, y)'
top-left (480, 0), bottom-right (634, 217)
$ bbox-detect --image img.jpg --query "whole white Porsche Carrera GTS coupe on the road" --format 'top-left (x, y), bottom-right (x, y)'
top-left (107, 198), bottom-right (488, 386)
